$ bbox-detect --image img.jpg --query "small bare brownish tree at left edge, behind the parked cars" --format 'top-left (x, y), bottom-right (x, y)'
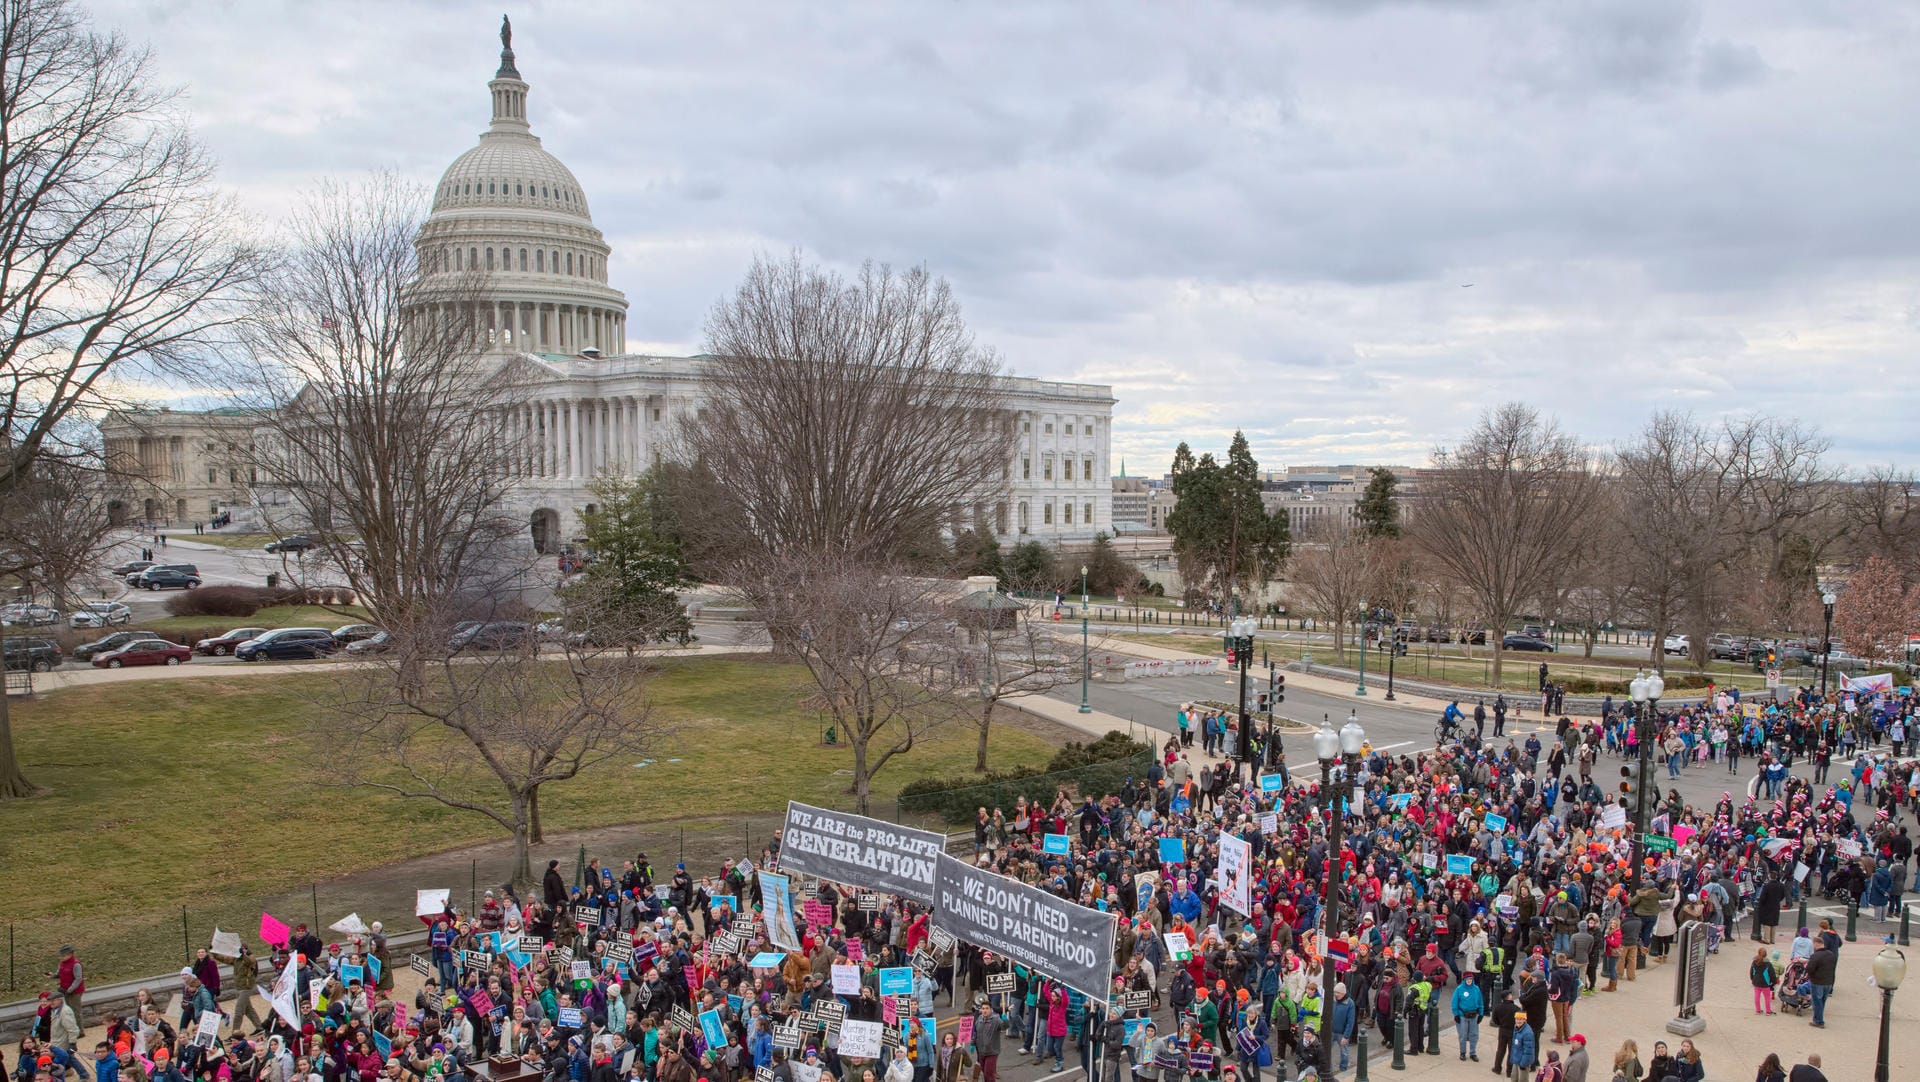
top-left (0, 457), bottom-right (119, 610)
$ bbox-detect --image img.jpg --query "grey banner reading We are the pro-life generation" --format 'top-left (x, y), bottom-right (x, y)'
top-left (780, 802), bottom-right (947, 902)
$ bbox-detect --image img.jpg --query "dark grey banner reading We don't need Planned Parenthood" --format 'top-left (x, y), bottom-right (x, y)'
top-left (935, 854), bottom-right (1114, 998)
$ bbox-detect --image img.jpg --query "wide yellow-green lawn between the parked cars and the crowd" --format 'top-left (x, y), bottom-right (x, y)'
top-left (0, 658), bottom-right (1054, 994)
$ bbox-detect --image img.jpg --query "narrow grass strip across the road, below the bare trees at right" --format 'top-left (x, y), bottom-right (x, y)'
top-left (1112, 631), bottom-right (1766, 694)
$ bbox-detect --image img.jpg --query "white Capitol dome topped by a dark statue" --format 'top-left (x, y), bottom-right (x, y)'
top-left (409, 23), bottom-right (626, 357)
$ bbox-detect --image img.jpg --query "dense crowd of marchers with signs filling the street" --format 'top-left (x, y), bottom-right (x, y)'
top-left (10, 679), bottom-right (1916, 1082)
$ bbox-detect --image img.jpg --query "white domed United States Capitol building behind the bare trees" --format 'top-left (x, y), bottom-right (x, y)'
top-left (102, 29), bottom-right (1114, 553)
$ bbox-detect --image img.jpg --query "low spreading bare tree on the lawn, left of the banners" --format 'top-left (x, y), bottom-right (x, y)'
top-left (313, 622), bottom-right (664, 886)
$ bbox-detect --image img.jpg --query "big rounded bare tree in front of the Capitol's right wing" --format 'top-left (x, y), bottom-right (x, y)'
top-left (682, 255), bottom-right (1014, 579)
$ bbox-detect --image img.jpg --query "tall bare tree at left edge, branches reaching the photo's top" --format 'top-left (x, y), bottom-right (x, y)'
top-left (0, 0), bottom-right (255, 800)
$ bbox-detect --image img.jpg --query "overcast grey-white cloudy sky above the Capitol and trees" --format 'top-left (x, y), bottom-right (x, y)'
top-left (92, 0), bottom-right (1920, 474)
